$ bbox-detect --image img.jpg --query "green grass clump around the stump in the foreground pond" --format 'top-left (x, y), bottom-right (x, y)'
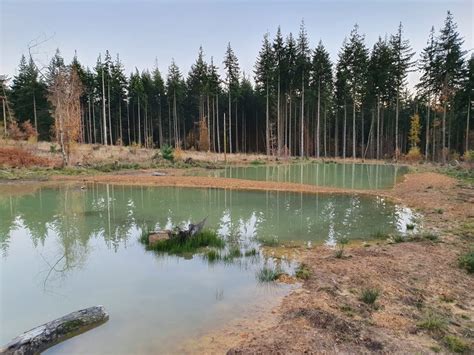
top-left (140, 229), bottom-right (225, 255)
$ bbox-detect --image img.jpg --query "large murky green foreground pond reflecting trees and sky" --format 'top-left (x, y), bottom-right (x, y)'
top-left (0, 184), bottom-right (414, 354)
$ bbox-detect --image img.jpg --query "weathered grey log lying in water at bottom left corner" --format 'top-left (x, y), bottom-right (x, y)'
top-left (0, 306), bottom-right (109, 355)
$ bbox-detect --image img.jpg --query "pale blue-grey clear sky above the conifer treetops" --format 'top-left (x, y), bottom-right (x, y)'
top-left (0, 0), bottom-right (474, 89)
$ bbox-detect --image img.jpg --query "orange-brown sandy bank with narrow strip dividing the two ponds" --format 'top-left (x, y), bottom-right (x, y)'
top-left (46, 170), bottom-right (474, 354)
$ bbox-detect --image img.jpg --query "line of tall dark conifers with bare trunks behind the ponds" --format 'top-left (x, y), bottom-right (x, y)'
top-left (2, 11), bottom-right (474, 162)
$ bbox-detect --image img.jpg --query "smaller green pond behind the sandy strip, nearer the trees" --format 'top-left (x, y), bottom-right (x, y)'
top-left (200, 162), bottom-right (408, 190)
